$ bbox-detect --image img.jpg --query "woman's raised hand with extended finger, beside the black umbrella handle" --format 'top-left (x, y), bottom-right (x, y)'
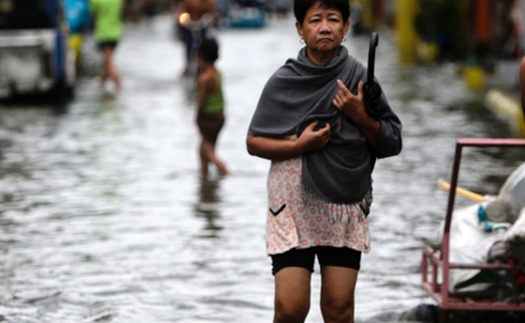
top-left (333, 80), bottom-right (367, 122)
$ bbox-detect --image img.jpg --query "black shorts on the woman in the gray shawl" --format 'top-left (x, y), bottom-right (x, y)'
top-left (271, 246), bottom-right (361, 275)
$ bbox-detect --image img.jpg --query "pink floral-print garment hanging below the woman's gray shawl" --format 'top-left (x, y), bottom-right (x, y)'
top-left (266, 157), bottom-right (370, 255)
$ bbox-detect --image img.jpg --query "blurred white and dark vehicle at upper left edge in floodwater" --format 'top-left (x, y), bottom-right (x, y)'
top-left (0, 0), bottom-right (76, 98)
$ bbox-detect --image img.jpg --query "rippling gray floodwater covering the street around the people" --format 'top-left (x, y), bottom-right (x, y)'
top-left (0, 16), bottom-right (524, 323)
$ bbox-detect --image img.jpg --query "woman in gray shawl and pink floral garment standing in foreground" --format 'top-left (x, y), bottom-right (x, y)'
top-left (246, 0), bottom-right (402, 323)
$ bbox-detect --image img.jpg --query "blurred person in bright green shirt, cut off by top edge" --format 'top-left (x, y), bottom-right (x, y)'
top-left (91, 0), bottom-right (124, 90)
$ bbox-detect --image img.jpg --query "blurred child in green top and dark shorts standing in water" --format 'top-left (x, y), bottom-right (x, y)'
top-left (197, 39), bottom-right (228, 178)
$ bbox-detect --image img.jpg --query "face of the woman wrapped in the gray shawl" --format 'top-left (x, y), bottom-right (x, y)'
top-left (295, 2), bottom-right (350, 61)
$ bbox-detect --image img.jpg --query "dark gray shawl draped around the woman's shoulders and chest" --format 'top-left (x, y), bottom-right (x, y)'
top-left (248, 47), bottom-right (402, 204)
